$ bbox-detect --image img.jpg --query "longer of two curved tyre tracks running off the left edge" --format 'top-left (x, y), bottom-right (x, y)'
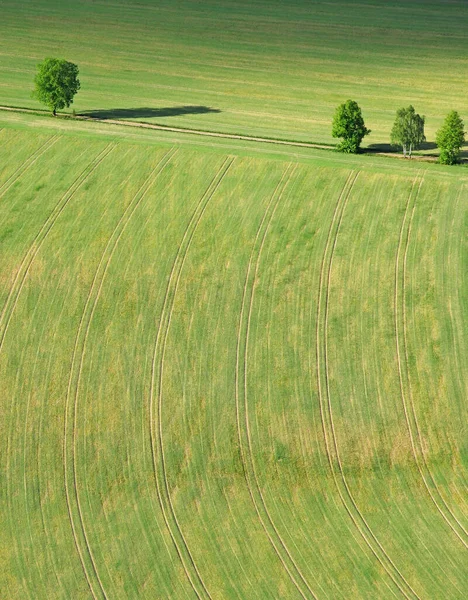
top-left (0, 144), bottom-right (115, 352)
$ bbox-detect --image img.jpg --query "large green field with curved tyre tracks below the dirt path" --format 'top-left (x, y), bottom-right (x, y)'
top-left (0, 115), bottom-right (468, 600)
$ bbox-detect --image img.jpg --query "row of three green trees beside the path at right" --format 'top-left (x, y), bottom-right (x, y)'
top-left (332, 100), bottom-right (465, 165)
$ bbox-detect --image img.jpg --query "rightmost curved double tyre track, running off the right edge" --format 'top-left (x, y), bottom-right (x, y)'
top-left (394, 178), bottom-right (468, 549)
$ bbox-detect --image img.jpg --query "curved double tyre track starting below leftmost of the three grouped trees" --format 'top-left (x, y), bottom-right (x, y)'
top-left (316, 172), bottom-right (420, 600)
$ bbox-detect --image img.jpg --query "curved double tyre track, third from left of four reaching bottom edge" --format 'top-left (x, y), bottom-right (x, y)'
top-left (236, 165), bottom-right (317, 600)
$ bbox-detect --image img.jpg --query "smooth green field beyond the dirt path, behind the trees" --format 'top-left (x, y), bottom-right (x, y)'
top-left (0, 0), bottom-right (468, 145)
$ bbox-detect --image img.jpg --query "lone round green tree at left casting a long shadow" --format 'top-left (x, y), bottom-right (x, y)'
top-left (33, 58), bottom-right (80, 116)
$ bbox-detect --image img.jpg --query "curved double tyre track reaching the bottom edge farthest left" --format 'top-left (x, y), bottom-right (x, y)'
top-left (63, 149), bottom-right (176, 599)
